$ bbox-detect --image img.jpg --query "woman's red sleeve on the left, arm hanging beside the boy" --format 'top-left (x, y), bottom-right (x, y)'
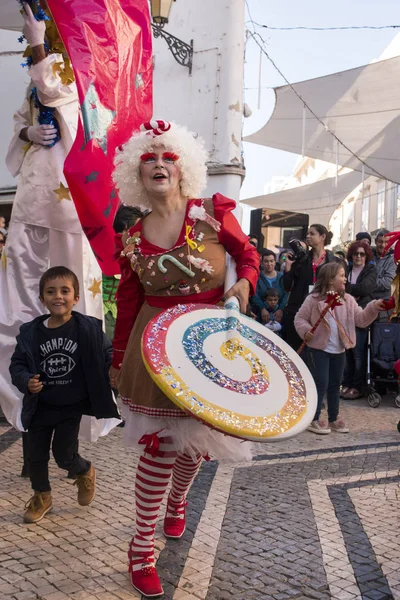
top-left (112, 235), bottom-right (144, 369)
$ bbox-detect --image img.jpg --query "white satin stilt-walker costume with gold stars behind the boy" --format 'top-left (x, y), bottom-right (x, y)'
top-left (0, 49), bottom-right (118, 440)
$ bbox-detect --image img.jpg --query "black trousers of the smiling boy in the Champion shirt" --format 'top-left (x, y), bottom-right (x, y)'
top-left (28, 402), bottom-right (90, 492)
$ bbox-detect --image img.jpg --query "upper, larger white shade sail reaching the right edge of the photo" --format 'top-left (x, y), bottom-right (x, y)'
top-left (245, 56), bottom-right (400, 183)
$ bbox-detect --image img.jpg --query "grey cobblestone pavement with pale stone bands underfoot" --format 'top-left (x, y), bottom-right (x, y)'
top-left (0, 397), bottom-right (400, 600)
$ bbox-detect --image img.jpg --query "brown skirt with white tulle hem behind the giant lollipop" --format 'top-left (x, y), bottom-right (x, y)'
top-left (118, 302), bottom-right (252, 461)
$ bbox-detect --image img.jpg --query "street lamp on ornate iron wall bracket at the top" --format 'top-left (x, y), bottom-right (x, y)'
top-left (150, 0), bottom-right (193, 75)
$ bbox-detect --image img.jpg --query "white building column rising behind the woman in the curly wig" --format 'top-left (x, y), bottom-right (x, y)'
top-left (154, 0), bottom-right (245, 216)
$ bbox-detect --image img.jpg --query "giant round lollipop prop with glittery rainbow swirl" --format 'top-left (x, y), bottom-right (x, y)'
top-left (142, 304), bottom-right (317, 441)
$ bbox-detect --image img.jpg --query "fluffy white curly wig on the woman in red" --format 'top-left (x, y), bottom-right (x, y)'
top-left (113, 123), bottom-right (208, 208)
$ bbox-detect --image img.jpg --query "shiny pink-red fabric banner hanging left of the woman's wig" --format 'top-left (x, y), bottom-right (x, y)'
top-left (47, 0), bottom-right (152, 275)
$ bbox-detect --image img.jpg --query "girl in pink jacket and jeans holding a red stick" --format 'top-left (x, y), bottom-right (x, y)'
top-left (294, 262), bottom-right (384, 434)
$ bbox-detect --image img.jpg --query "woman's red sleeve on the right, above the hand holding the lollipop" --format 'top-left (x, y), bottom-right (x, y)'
top-left (213, 194), bottom-right (260, 296)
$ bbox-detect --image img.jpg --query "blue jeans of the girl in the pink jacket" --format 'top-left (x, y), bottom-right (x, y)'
top-left (307, 348), bottom-right (346, 423)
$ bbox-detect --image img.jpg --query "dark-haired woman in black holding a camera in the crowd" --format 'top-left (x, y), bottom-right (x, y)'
top-left (282, 224), bottom-right (337, 350)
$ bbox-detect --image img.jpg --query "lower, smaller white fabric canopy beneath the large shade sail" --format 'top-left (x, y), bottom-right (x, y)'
top-left (241, 171), bottom-right (361, 227)
